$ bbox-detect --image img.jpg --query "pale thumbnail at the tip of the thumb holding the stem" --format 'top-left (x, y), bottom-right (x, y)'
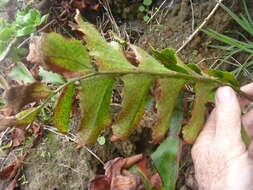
top-left (215, 86), bottom-right (234, 103)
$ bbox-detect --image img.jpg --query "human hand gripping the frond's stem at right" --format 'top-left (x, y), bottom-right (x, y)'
top-left (192, 83), bottom-right (253, 190)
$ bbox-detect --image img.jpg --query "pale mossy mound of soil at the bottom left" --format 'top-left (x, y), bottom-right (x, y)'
top-left (22, 133), bottom-right (95, 190)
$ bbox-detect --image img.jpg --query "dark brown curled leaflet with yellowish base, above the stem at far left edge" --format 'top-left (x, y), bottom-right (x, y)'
top-left (4, 82), bottom-right (51, 114)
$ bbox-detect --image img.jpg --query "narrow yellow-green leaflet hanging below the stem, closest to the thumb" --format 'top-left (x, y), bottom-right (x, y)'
top-left (183, 82), bottom-right (215, 144)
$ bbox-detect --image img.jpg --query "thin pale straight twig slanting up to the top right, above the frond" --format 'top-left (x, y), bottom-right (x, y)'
top-left (177, 0), bottom-right (223, 53)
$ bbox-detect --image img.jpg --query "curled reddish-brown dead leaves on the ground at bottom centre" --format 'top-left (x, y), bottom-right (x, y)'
top-left (89, 154), bottom-right (162, 190)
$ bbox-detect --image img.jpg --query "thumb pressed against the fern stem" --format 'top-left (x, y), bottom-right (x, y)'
top-left (216, 86), bottom-right (242, 146)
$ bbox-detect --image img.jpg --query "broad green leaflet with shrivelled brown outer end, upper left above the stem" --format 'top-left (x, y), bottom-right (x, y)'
top-left (27, 33), bottom-right (93, 76)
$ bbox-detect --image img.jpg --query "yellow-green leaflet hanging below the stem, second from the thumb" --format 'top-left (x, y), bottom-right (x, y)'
top-left (152, 78), bottom-right (186, 143)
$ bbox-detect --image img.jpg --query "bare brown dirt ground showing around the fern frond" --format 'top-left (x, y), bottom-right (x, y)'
top-left (0, 0), bottom-right (250, 190)
